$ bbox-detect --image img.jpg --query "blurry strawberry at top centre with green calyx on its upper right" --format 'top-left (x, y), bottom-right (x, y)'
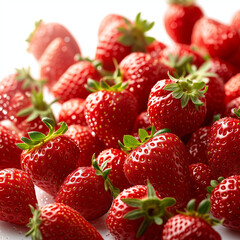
top-left (95, 13), bottom-right (154, 71)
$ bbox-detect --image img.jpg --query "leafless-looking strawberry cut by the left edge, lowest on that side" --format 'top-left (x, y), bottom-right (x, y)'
top-left (0, 168), bottom-right (37, 225)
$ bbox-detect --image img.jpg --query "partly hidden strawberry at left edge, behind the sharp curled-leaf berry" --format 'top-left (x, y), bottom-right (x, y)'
top-left (0, 125), bottom-right (22, 169)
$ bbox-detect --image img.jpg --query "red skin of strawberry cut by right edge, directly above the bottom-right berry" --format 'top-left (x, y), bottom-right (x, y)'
top-left (207, 117), bottom-right (240, 179)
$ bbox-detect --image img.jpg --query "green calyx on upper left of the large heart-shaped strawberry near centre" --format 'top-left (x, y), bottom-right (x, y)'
top-left (118, 125), bottom-right (170, 154)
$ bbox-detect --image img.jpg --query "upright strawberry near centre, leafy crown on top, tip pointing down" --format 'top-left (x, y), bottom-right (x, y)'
top-left (85, 80), bottom-right (138, 148)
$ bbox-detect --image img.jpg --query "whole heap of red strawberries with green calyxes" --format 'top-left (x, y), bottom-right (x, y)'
top-left (0, 0), bottom-right (240, 240)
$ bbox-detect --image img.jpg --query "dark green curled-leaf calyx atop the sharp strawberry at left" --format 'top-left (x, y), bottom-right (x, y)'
top-left (16, 118), bottom-right (68, 151)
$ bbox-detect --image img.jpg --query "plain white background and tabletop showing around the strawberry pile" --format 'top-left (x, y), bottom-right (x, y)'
top-left (0, 0), bottom-right (240, 240)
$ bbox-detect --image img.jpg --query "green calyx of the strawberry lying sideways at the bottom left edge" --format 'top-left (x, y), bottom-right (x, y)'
top-left (25, 205), bottom-right (43, 240)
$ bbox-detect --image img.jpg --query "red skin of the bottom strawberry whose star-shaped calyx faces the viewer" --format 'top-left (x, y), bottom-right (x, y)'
top-left (106, 185), bottom-right (163, 240)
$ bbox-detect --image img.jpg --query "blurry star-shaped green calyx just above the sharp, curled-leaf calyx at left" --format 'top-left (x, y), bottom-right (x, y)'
top-left (17, 89), bottom-right (58, 122)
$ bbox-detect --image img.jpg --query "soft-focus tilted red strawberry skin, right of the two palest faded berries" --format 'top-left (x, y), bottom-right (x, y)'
top-left (52, 61), bottom-right (101, 103)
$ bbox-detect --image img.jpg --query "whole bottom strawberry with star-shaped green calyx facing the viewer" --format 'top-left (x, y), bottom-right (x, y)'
top-left (106, 182), bottom-right (175, 240)
